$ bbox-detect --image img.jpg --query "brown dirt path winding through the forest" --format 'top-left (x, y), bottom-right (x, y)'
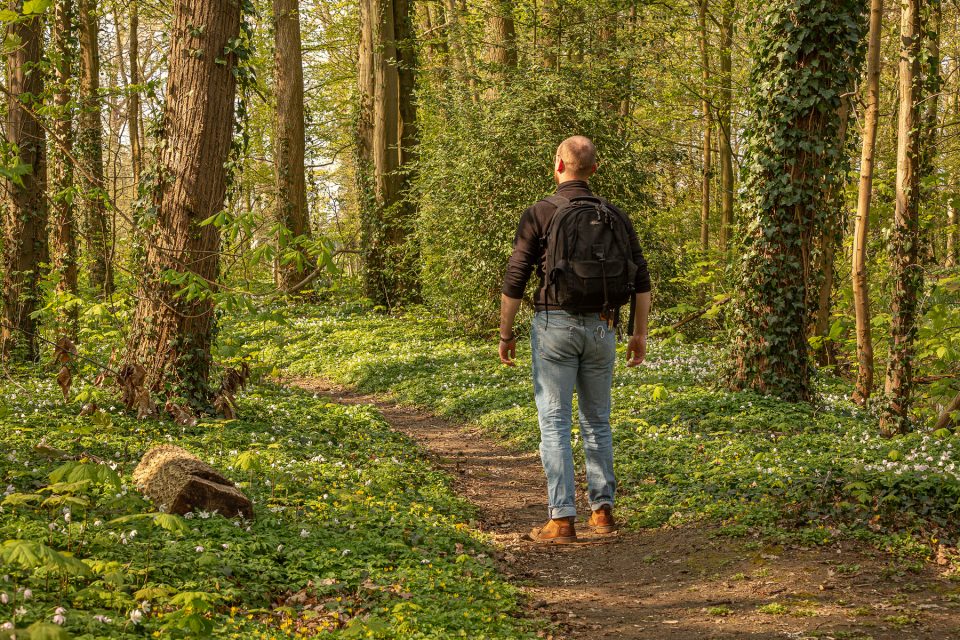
top-left (294, 379), bottom-right (960, 640)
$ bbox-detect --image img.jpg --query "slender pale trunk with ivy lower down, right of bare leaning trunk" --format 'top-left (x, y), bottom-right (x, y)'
top-left (880, 0), bottom-right (923, 435)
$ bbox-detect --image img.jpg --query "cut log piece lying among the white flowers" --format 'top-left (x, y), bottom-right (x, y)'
top-left (133, 444), bottom-right (253, 520)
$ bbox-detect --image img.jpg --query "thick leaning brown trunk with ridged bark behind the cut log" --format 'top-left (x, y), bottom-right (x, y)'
top-left (126, 0), bottom-right (240, 404)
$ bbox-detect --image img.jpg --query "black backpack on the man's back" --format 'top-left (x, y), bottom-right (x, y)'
top-left (544, 195), bottom-right (637, 317)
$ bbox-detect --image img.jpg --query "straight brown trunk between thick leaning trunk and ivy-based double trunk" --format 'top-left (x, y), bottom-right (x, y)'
top-left (273, 0), bottom-right (310, 291)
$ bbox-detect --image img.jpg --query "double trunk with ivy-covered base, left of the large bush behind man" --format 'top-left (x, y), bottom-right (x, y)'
top-left (358, 0), bottom-right (418, 307)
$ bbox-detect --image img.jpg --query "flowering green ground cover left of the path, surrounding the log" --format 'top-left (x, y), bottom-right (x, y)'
top-left (0, 374), bottom-right (531, 640)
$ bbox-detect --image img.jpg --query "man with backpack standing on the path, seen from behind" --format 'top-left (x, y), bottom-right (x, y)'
top-left (500, 136), bottom-right (650, 543)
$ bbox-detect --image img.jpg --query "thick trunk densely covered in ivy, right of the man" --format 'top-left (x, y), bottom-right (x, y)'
top-left (729, 0), bottom-right (865, 401)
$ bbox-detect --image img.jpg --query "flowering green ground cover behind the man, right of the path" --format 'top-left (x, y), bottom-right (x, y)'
top-left (222, 303), bottom-right (960, 554)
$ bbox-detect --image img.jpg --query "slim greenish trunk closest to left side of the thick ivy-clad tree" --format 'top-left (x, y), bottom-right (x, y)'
top-left (717, 0), bottom-right (736, 254)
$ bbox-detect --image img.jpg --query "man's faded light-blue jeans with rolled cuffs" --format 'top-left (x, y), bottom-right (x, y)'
top-left (531, 311), bottom-right (617, 518)
